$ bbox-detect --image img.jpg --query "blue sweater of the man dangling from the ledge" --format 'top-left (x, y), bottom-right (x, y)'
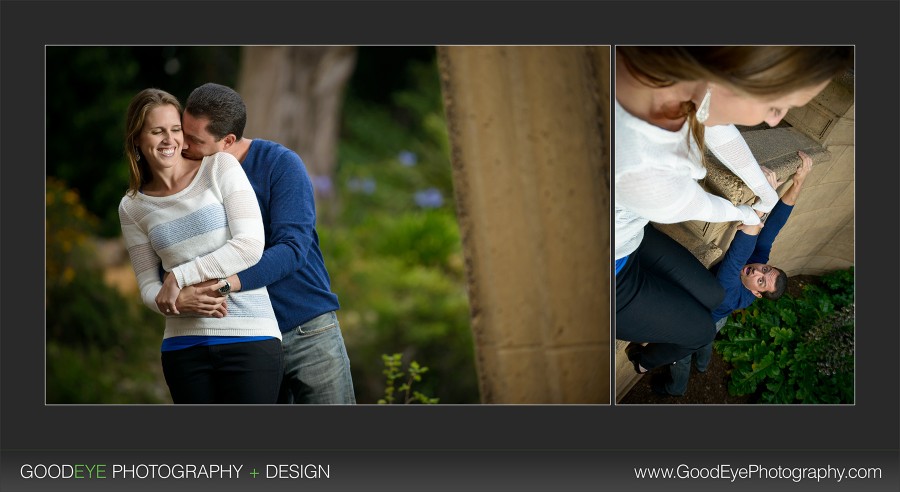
top-left (712, 200), bottom-right (794, 321)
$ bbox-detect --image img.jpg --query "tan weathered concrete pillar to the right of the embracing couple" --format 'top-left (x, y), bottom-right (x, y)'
top-left (438, 47), bottom-right (610, 403)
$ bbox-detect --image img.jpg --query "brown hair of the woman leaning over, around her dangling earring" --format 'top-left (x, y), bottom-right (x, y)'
top-left (616, 46), bottom-right (853, 160)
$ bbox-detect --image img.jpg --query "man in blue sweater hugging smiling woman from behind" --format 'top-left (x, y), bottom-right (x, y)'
top-left (176, 83), bottom-right (356, 404)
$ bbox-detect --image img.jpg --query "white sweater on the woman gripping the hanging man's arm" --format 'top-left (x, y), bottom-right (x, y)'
top-left (614, 101), bottom-right (778, 259)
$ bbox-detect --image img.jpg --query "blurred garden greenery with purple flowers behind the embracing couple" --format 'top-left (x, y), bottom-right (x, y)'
top-left (46, 46), bottom-right (479, 404)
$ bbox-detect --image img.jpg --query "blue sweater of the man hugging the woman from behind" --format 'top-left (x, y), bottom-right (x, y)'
top-left (238, 139), bottom-right (340, 333)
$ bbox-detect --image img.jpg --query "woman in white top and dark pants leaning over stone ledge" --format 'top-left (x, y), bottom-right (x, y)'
top-left (615, 46), bottom-right (853, 373)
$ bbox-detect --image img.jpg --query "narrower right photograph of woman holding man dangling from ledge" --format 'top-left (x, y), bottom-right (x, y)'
top-left (613, 46), bottom-right (855, 405)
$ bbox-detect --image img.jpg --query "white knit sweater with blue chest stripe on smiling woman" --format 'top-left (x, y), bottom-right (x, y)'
top-left (119, 152), bottom-right (281, 338)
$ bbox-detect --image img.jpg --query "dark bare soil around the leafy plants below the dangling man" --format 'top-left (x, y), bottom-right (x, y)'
top-left (618, 275), bottom-right (818, 405)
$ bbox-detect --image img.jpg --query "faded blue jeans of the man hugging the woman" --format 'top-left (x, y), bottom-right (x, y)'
top-left (278, 311), bottom-right (356, 405)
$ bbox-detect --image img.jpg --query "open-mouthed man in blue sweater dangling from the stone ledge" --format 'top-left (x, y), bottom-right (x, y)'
top-left (650, 151), bottom-right (812, 396)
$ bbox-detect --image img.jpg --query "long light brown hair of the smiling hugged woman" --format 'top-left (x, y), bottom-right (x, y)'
top-left (125, 89), bottom-right (181, 196)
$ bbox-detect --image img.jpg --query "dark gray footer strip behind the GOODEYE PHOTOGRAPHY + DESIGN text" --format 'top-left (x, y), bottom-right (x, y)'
top-left (2, 449), bottom-right (897, 492)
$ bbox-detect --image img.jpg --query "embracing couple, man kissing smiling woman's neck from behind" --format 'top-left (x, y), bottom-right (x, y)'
top-left (119, 83), bottom-right (355, 404)
